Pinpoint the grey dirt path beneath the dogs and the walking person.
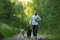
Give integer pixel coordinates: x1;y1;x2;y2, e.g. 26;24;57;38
2;33;49;40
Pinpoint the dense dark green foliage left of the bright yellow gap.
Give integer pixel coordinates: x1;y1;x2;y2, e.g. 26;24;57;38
0;0;25;37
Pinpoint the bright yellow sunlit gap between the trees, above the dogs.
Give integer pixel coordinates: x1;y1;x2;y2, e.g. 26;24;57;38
18;0;32;18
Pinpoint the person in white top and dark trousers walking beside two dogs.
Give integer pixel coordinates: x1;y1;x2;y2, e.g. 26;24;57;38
29;11;41;39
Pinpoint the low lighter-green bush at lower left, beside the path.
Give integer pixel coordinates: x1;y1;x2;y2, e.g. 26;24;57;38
0;24;18;37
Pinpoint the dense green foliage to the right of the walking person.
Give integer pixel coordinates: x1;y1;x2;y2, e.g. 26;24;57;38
34;0;60;37
